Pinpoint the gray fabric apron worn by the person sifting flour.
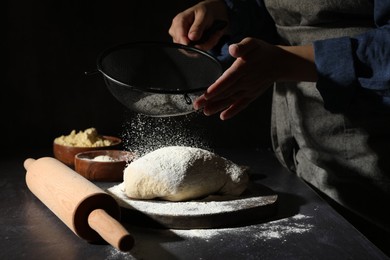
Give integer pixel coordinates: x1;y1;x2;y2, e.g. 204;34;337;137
264;0;390;231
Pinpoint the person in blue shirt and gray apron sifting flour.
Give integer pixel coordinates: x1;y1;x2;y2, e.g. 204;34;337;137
169;0;390;253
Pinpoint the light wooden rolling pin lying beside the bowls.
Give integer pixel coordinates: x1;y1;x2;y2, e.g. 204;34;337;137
24;157;134;252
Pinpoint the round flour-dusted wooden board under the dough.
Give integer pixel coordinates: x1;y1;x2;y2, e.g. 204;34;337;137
107;184;278;229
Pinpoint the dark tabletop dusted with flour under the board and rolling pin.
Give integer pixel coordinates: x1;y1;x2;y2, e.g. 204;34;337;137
0;147;388;259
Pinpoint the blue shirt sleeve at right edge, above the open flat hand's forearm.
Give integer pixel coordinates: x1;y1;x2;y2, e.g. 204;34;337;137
314;0;390;112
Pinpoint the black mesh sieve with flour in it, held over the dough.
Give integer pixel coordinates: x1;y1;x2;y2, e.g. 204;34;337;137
97;42;222;117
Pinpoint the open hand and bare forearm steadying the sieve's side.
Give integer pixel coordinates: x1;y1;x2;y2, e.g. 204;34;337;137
194;38;317;120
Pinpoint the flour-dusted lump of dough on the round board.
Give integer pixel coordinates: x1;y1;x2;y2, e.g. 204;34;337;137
123;146;248;201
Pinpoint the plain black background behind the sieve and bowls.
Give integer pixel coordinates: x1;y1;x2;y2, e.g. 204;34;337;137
0;0;270;153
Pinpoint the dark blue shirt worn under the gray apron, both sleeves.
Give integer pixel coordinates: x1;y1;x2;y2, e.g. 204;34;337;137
222;0;390;112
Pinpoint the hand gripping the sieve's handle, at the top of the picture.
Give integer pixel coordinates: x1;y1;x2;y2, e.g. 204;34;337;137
169;0;228;51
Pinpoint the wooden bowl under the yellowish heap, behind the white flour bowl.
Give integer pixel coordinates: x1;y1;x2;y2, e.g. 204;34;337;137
53;135;122;169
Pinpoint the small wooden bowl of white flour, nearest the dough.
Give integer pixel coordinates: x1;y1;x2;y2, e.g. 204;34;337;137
74;150;135;182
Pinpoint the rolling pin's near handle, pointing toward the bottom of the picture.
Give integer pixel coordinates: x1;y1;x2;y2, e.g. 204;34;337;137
88;209;134;252
